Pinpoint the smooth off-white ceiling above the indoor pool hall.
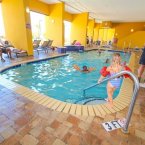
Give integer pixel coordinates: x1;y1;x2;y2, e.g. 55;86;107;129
40;0;145;22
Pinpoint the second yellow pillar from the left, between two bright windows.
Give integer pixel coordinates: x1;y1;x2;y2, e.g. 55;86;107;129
46;3;64;46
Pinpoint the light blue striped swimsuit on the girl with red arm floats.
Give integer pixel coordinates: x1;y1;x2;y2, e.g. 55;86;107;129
109;73;122;88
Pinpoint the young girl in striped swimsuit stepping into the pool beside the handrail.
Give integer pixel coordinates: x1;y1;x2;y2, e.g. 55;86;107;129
98;53;124;107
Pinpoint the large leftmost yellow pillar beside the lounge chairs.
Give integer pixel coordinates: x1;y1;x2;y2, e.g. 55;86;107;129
2;0;33;55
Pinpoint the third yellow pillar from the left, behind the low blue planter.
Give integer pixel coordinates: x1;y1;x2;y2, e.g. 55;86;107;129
71;12;89;45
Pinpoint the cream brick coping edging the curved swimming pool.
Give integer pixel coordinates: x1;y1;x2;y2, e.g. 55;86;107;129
0;54;134;117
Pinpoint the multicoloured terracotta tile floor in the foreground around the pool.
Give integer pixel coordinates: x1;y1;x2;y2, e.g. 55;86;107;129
0;50;145;145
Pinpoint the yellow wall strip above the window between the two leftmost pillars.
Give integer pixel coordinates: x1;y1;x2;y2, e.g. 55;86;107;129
29;0;50;15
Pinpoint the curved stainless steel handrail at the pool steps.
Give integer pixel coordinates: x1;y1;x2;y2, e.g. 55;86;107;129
83;71;139;133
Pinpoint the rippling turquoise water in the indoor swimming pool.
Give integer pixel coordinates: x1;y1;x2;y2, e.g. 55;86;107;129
2;51;129;103
